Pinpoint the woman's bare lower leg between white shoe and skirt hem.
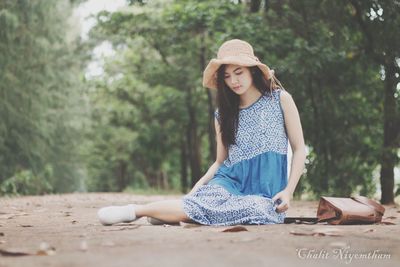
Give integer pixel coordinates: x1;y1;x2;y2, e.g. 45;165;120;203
135;199;190;223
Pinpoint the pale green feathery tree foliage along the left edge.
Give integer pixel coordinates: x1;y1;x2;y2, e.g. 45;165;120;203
0;0;85;193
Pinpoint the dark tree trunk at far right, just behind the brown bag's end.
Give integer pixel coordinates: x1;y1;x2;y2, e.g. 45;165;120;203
380;58;399;204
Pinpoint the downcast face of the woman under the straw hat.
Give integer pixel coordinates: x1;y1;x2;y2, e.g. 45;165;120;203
224;65;253;95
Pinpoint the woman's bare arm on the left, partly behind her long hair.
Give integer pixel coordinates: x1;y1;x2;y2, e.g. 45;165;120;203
189;119;228;194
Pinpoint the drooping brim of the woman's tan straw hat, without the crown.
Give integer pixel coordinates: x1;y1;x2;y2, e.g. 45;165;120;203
203;56;271;89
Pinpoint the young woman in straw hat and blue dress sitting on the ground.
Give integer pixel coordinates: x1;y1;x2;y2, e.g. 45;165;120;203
98;39;306;225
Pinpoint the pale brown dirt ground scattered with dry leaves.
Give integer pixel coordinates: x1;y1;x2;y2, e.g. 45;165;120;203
0;193;400;267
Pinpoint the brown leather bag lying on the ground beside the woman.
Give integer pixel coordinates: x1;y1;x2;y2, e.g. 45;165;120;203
317;196;385;224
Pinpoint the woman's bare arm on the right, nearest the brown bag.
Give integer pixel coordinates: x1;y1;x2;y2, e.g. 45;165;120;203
273;91;306;211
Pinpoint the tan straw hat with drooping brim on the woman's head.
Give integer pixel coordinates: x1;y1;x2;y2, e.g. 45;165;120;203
203;39;273;89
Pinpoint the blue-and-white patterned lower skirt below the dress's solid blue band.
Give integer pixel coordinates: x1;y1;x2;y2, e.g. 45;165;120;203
183;184;286;226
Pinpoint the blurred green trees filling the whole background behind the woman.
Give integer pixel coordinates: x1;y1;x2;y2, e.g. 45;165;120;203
0;0;400;204
